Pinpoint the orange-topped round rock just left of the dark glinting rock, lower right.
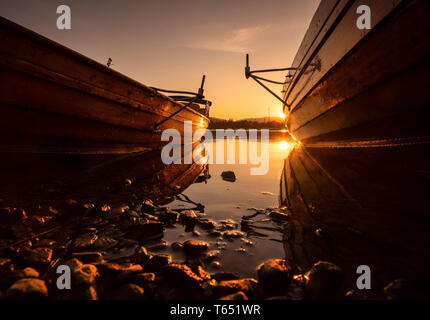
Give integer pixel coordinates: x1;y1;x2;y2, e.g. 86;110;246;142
257;259;293;295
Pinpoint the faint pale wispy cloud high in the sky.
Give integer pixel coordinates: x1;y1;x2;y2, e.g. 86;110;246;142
189;26;268;53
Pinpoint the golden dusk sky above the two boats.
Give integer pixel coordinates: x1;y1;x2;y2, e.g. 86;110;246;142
0;0;319;119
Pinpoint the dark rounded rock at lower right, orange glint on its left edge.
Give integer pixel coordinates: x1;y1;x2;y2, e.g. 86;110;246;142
304;261;344;300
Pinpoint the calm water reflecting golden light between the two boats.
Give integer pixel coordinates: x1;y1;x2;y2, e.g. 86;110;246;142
160;136;294;277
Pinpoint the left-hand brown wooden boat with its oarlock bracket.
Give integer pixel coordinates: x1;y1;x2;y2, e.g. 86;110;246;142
0;17;210;154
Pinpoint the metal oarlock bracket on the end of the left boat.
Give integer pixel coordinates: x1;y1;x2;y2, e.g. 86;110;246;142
151;75;212;130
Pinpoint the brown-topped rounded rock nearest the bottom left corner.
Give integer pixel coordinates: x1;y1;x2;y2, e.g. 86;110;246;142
6;278;48;300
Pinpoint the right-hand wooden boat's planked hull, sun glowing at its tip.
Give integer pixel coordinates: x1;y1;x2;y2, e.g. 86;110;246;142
284;0;430;144
